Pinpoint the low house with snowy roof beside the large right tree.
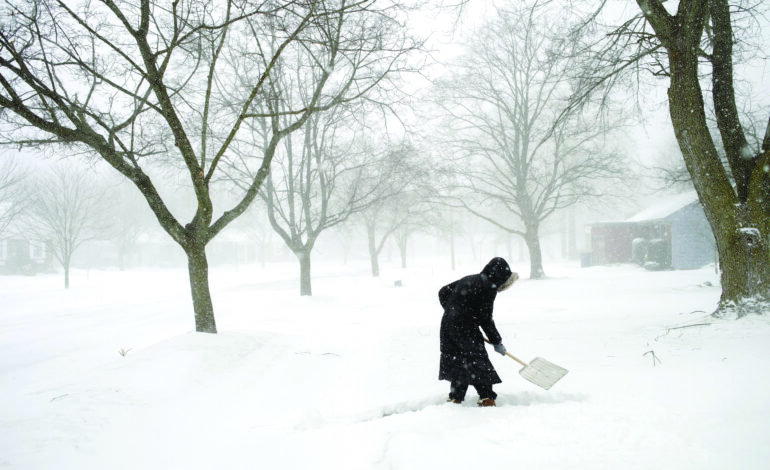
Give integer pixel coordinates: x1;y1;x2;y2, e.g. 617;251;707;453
584;191;715;269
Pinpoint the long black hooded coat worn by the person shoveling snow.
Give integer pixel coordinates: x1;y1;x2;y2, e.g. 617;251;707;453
438;258;511;384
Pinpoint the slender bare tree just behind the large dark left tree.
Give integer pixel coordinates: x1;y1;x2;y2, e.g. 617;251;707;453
262;110;396;295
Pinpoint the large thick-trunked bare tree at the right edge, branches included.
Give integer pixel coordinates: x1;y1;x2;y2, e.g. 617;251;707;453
574;0;770;316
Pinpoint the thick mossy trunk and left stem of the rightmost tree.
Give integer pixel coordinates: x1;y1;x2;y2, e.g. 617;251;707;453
667;4;770;316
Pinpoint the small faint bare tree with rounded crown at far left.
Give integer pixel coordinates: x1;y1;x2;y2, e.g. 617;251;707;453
25;163;108;289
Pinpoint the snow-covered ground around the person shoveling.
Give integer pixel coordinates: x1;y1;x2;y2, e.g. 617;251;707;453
0;262;770;470
